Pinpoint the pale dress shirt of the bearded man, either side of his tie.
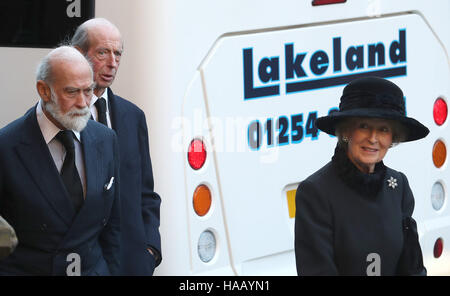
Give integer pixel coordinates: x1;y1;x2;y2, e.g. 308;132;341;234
36;101;86;197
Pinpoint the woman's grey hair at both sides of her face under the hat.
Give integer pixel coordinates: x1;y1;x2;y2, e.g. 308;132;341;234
335;117;408;148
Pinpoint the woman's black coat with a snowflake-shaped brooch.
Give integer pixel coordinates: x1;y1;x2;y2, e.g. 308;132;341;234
295;150;422;275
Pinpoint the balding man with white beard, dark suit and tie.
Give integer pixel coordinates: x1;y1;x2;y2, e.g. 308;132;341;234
0;46;120;275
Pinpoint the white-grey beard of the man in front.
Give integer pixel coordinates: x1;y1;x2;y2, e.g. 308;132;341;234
43;89;91;132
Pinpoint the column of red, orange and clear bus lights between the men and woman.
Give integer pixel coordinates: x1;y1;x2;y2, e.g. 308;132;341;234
188;139;217;263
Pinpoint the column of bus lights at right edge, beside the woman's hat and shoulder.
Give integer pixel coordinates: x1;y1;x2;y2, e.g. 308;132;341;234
431;98;448;258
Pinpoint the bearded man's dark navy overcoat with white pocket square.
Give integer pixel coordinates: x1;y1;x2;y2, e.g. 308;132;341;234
0;108;120;275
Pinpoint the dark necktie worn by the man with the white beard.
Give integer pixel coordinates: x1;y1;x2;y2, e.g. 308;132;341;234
56;130;84;212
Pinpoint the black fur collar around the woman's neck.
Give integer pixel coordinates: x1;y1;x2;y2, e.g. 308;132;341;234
332;144;386;198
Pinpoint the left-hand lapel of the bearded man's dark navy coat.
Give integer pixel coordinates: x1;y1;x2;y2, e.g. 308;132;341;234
16;108;75;225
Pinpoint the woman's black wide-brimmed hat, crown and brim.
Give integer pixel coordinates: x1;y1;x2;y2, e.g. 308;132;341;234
316;77;430;142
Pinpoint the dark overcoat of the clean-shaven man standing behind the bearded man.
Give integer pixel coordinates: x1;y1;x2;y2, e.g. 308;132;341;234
107;88;161;275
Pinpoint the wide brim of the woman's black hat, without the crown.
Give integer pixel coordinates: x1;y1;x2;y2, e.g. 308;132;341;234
315;108;430;142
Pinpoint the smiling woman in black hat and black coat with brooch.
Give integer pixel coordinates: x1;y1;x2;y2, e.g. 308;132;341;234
295;77;429;275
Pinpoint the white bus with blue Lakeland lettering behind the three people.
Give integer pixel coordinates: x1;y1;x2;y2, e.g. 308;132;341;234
0;0;450;275
